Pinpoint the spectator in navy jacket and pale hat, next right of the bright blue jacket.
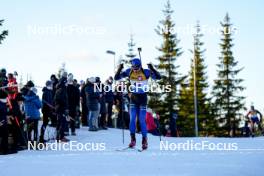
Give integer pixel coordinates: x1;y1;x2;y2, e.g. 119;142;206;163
39;81;55;143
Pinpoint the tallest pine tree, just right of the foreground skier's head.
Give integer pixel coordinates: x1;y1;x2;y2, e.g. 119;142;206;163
149;1;183;136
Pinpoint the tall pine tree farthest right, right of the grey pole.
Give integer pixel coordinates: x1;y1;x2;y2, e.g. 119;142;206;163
212;14;245;136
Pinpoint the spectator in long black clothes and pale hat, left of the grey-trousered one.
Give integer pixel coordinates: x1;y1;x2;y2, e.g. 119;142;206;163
67;73;80;136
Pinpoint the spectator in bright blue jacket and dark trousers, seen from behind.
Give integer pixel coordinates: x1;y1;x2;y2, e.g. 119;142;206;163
24;87;42;142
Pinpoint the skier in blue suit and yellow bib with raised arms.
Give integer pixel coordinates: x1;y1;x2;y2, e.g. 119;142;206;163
115;58;161;150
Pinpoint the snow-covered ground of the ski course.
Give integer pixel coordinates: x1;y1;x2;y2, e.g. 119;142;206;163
0;128;264;176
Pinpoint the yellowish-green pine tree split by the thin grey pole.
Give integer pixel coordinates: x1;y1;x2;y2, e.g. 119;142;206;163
178;22;213;136
